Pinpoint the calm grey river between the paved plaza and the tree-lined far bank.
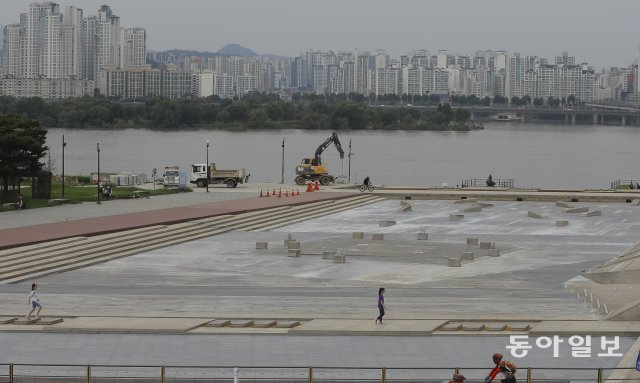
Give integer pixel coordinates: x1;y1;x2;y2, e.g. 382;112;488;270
47;122;640;189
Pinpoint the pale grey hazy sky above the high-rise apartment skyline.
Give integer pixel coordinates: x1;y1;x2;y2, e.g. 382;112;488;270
0;0;640;68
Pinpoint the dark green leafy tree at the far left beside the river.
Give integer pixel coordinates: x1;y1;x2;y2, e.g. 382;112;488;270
0;114;49;198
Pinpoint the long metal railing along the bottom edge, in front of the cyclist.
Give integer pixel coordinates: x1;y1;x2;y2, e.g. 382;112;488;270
0;363;638;383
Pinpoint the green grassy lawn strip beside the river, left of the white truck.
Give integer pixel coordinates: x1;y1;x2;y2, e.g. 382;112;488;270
0;181;192;211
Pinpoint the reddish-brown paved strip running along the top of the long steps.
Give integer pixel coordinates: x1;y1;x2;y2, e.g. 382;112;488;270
0;192;354;249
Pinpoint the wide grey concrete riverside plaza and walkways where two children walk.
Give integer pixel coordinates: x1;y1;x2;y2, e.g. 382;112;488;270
0;185;640;379
